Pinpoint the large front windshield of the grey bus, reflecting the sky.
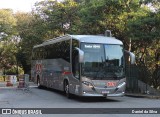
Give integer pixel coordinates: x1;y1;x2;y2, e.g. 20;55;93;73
81;43;124;80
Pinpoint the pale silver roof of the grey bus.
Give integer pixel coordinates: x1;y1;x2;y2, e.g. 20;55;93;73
34;35;123;48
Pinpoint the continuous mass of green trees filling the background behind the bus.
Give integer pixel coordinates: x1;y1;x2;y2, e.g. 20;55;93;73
0;0;160;88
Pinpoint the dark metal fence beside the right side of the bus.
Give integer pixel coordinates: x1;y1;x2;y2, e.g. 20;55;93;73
126;65;160;95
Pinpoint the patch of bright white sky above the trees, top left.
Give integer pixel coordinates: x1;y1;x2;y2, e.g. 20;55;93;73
0;0;43;12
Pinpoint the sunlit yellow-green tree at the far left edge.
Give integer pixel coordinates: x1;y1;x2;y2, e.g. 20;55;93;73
0;9;17;74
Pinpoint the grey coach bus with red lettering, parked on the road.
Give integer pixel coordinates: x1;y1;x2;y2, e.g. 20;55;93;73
31;34;135;98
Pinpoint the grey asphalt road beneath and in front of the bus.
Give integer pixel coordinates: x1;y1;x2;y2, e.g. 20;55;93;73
0;82;160;117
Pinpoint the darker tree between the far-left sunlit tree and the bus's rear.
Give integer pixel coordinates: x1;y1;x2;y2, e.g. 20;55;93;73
15;12;45;73
